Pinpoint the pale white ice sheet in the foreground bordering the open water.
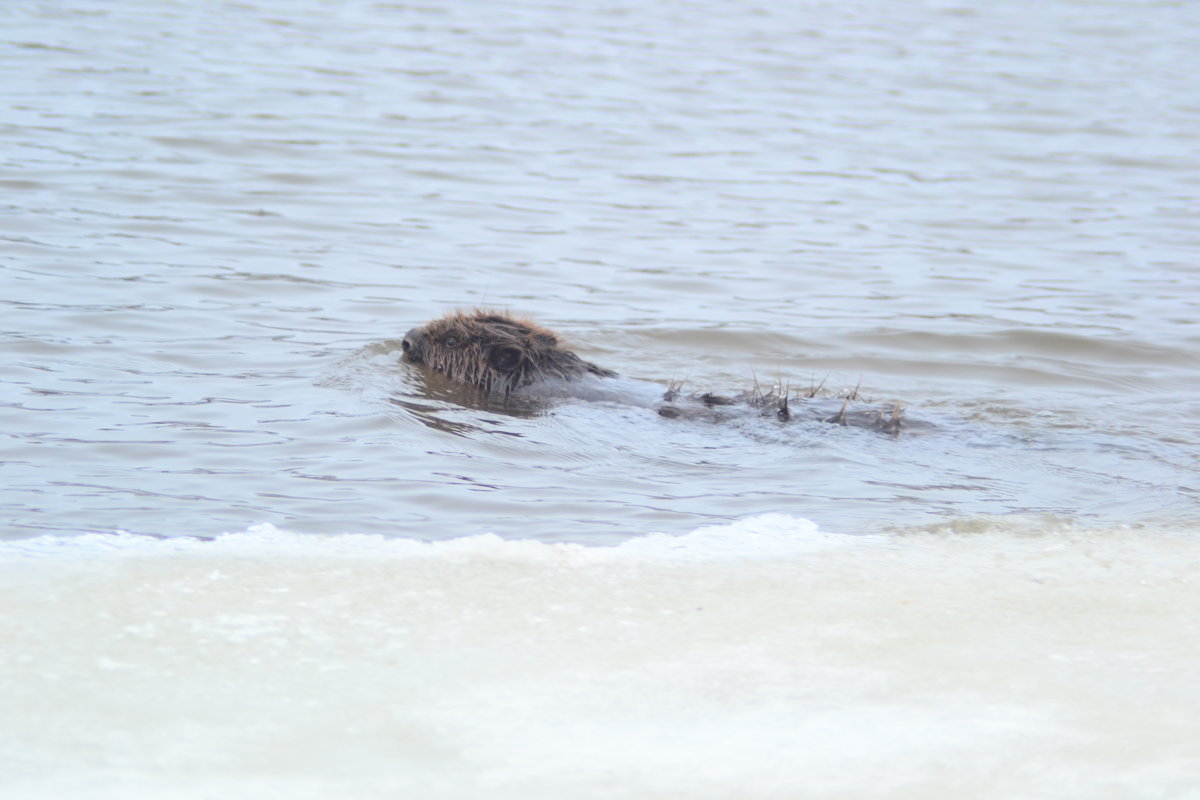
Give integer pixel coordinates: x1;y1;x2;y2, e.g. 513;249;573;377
0;515;1200;798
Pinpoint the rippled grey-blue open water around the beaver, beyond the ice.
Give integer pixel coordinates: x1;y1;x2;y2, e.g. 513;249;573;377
2;2;1200;541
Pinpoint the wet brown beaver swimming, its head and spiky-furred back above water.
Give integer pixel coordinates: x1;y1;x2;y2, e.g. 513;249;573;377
401;309;900;433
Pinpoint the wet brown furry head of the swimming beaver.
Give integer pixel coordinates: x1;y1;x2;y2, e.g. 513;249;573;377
402;311;617;399
